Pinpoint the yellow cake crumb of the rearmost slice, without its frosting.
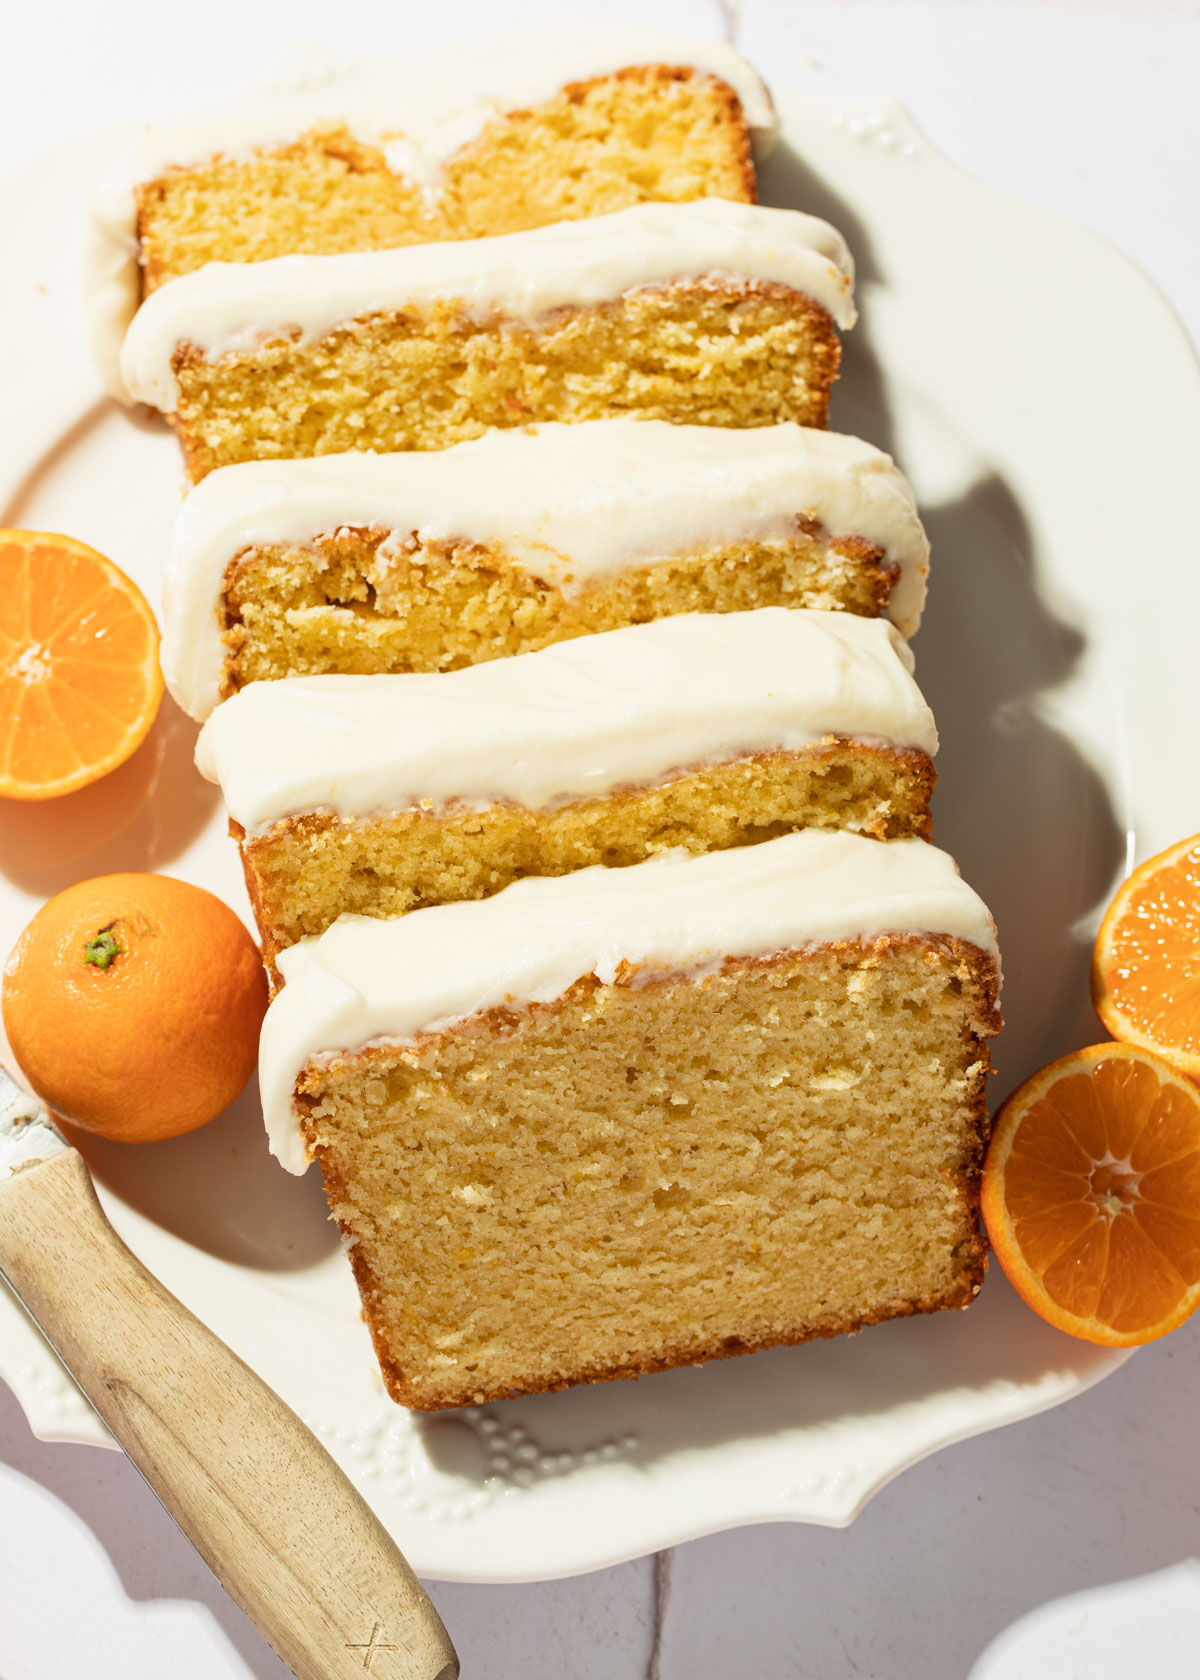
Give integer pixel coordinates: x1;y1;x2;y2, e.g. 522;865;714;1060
138;66;755;292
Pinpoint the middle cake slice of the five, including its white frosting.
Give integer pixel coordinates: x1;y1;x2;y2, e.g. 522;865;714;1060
163;420;929;719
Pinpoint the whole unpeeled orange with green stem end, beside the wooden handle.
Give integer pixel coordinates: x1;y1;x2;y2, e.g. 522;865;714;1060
2;875;267;1142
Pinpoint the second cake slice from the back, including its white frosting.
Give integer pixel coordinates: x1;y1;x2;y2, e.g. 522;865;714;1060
121;198;854;480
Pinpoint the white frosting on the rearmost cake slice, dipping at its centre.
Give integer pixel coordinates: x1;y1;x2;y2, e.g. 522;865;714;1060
84;22;778;396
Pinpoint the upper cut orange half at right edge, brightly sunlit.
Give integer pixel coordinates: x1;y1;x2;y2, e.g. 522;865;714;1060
1092;835;1200;1079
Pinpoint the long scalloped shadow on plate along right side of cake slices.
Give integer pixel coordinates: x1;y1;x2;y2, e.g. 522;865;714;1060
760;127;1129;1075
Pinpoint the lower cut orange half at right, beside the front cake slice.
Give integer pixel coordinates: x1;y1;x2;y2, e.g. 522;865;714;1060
983;1045;1200;1347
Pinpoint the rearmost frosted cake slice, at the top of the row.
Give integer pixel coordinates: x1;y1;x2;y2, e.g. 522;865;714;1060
89;24;776;393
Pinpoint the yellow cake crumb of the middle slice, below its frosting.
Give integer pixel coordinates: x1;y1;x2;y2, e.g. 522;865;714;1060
216;519;899;696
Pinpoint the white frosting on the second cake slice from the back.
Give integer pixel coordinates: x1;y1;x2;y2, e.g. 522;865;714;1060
121;198;855;413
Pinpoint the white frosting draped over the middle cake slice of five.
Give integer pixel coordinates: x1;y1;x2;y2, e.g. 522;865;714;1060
161;420;929;719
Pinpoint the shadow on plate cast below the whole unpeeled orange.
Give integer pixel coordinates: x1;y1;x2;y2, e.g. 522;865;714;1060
64;1079;338;1272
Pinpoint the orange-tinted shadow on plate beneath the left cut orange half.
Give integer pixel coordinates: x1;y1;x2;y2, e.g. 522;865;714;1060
0;696;220;897
